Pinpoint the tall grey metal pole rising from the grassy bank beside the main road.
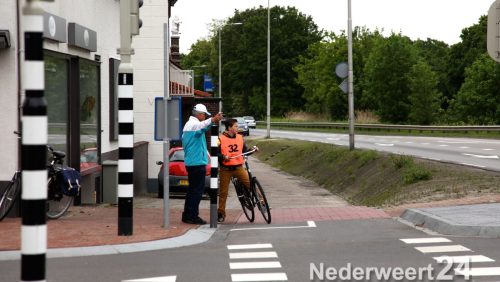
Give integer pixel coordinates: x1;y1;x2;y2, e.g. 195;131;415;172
347;0;354;150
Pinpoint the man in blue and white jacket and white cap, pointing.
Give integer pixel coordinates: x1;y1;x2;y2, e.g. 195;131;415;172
182;104;222;224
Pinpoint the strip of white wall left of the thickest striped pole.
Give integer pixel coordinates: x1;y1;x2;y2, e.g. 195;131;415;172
0;0;18;181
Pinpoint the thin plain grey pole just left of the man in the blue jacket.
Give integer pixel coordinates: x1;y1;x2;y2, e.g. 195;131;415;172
163;21;170;229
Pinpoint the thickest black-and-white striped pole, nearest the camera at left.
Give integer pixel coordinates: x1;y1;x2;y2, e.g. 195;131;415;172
21;1;48;281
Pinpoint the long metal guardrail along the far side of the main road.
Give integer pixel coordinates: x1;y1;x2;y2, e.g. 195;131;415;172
257;121;500;132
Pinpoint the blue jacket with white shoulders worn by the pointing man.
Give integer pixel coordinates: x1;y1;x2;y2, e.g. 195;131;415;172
182;116;212;166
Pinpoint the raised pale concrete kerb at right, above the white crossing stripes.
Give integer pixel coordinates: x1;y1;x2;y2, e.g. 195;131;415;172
401;209;500;238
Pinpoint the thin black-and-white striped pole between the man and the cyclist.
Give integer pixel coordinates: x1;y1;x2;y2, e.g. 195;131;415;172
210;124;219;228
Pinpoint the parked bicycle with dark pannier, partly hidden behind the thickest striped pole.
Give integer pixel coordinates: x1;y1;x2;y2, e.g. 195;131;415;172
0;138;80;221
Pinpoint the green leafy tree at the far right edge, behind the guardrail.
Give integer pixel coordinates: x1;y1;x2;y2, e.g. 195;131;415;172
450;53;500;125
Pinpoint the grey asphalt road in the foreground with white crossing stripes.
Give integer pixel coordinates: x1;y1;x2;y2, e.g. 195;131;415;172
0;219;500;282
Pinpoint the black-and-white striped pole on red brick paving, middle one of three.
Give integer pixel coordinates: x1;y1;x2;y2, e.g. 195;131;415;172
118;69;134;236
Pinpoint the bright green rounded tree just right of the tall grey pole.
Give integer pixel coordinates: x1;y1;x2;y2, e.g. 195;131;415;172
364;34;417;123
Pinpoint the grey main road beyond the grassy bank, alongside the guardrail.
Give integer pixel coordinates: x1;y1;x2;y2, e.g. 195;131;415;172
250;129;500;171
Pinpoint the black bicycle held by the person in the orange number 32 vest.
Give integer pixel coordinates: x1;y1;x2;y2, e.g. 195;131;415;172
231;147;271;224
